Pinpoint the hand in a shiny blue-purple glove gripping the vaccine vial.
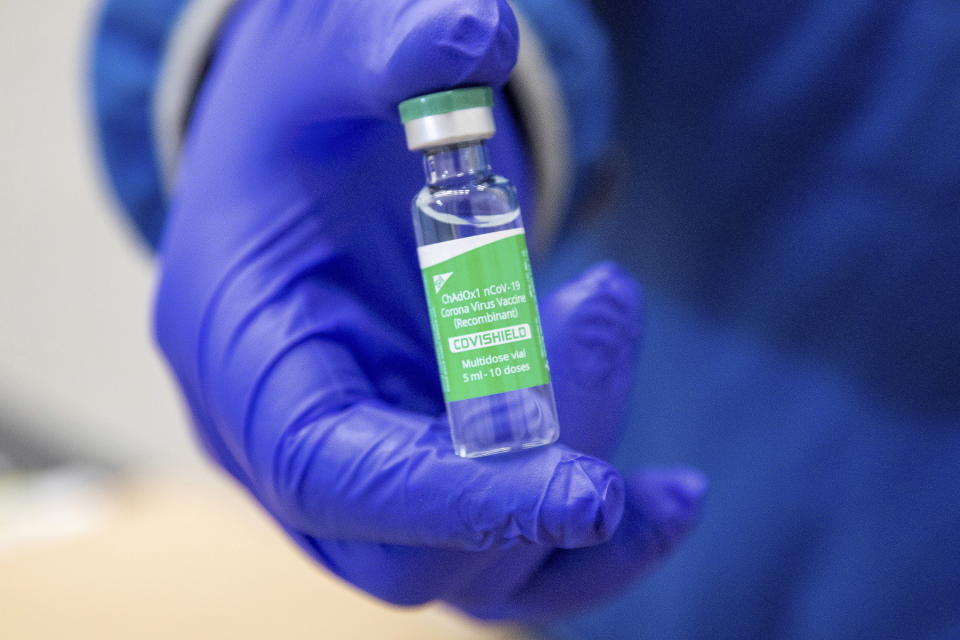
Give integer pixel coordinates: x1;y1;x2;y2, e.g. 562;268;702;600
156;0;704;619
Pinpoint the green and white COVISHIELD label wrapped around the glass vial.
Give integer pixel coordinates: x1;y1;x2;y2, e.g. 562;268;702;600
418;229;550;402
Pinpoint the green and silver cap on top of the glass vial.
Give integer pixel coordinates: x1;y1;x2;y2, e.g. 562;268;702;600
397;87;496;151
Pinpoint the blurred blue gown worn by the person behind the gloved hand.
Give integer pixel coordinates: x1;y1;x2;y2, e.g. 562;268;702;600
97;0;960;640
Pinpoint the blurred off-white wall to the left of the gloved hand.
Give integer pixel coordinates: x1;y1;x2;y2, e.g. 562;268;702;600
0;0;198;476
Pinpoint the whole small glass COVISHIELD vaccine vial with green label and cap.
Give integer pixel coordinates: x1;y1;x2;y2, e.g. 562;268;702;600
399;87;559;458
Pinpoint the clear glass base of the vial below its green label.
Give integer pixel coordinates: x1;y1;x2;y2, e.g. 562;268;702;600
447;384;560;458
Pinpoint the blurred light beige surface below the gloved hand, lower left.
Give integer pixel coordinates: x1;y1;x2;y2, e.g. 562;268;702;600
0;472;519;640
